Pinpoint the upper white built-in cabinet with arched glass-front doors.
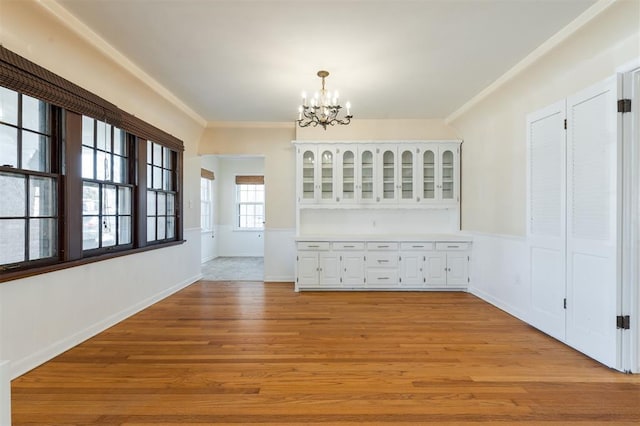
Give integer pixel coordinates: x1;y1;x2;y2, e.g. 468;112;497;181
296;141;460;207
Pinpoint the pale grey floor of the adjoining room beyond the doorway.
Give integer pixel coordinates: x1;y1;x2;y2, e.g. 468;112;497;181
202;257;264;281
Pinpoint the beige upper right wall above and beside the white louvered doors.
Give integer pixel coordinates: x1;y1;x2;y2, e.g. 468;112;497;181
451;0;640;235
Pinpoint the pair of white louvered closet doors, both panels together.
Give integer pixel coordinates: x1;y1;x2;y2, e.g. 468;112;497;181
527;78;622;368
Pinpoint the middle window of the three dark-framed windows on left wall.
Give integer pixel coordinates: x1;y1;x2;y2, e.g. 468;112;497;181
82;116;133;250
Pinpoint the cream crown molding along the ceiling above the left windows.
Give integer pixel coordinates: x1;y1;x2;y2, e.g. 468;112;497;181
36;0;207;127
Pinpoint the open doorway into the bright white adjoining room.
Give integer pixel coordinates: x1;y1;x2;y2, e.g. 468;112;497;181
201;155;266;281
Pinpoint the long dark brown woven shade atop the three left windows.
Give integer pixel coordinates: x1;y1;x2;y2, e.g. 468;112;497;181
0;46;184;151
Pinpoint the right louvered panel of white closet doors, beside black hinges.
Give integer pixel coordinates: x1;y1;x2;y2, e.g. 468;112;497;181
567;78;621;367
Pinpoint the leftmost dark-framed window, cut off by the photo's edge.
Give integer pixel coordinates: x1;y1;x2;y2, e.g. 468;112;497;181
0;87;59;267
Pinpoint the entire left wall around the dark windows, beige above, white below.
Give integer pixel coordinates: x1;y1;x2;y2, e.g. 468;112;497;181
0;0;204;382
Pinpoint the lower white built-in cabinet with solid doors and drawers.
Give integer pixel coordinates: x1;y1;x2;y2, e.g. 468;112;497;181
296;240;471;290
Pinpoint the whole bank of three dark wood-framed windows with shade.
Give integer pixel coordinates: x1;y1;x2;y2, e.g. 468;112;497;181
0;46;184;282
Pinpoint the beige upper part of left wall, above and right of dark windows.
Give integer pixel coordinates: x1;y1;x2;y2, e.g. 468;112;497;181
0;0;204;228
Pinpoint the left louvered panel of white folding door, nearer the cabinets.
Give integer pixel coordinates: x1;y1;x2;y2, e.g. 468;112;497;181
527;101;566;340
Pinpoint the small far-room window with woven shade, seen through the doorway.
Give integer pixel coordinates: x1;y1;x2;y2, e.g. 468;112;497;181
236;176;264;230
